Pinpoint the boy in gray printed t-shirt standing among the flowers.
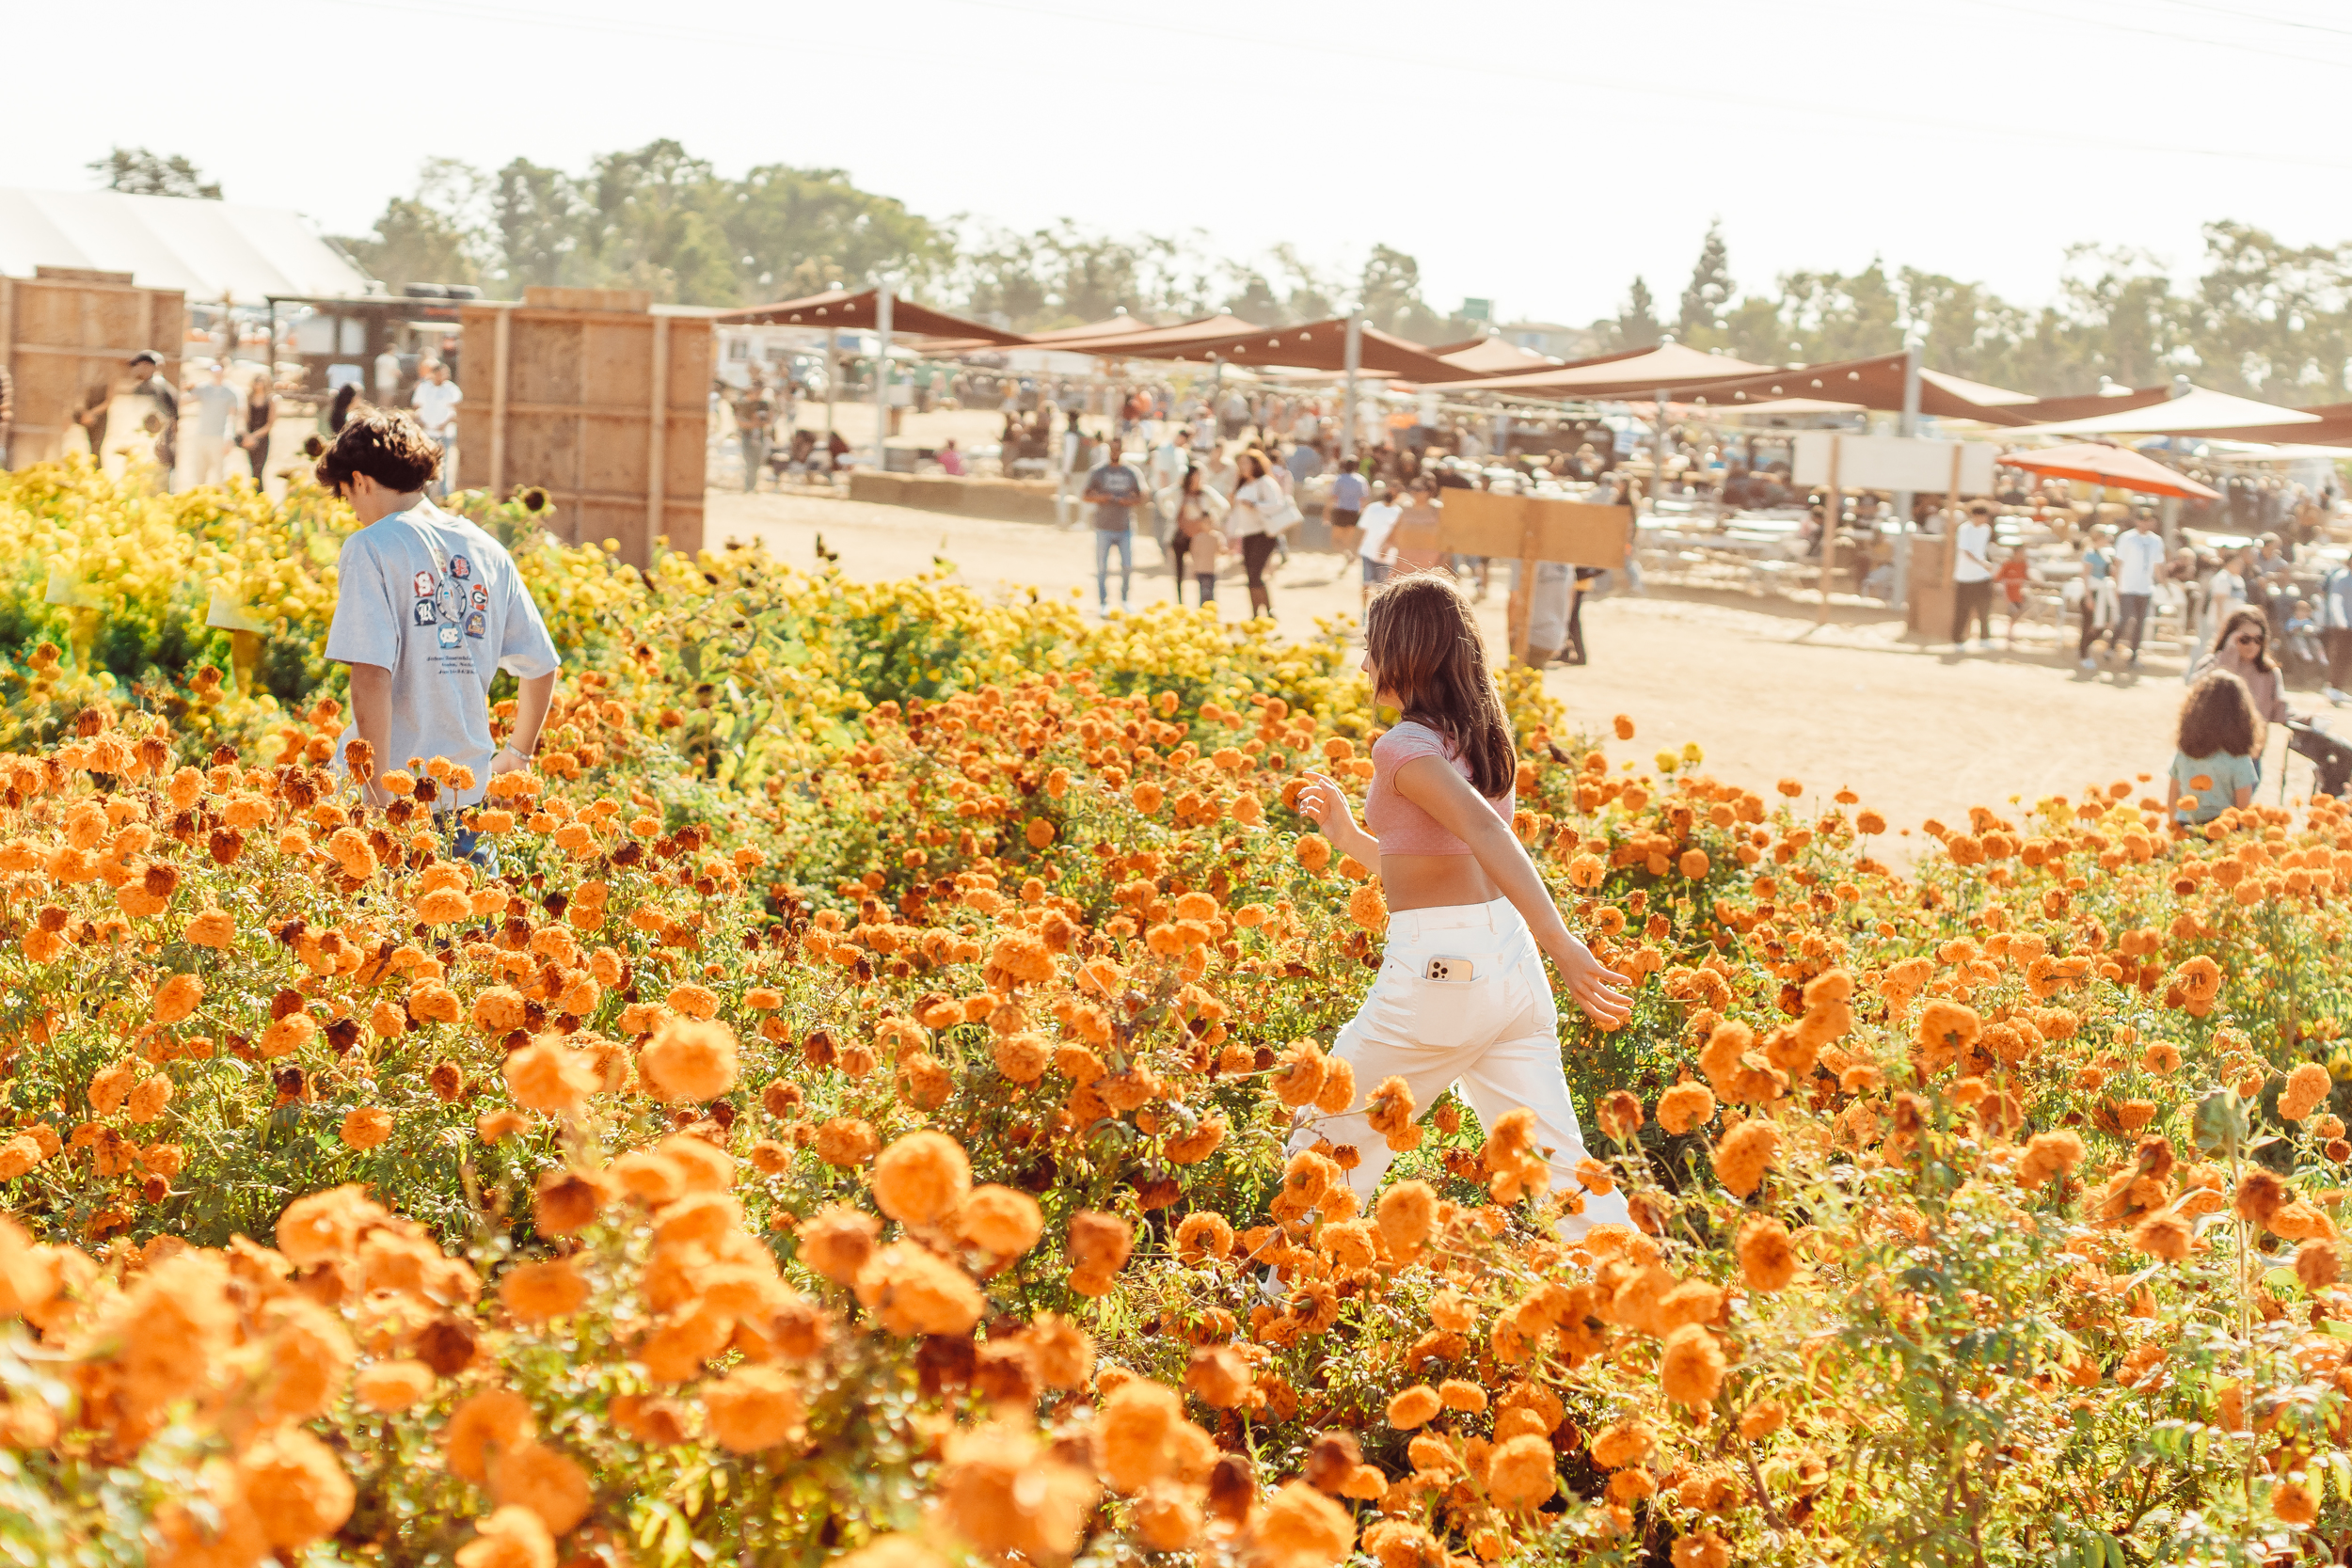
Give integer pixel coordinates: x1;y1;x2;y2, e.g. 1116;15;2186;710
318;409;563;811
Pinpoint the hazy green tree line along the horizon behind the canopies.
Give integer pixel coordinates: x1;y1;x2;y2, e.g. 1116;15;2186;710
89;141;2352;404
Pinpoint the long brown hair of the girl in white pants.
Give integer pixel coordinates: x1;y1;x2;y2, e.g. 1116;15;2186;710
1364;571;1519;800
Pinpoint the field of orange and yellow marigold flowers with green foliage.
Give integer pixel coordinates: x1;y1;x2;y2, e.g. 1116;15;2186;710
0;472;2352;1568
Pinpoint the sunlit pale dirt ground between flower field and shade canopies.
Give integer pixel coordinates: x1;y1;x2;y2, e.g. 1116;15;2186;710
706;491;2314;861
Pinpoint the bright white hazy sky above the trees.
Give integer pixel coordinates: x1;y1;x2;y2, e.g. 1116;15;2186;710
18;0;2352;322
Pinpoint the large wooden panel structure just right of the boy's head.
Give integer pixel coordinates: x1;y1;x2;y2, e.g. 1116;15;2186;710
459;289;710;566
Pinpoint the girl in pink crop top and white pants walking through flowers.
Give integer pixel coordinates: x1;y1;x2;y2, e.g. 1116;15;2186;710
1292;571;1632;1239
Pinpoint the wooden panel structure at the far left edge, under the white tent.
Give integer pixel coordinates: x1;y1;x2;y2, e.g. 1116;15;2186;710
0;265;188;467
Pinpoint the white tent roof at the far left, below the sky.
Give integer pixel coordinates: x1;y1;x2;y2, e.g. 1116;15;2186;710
0;188;381;306
